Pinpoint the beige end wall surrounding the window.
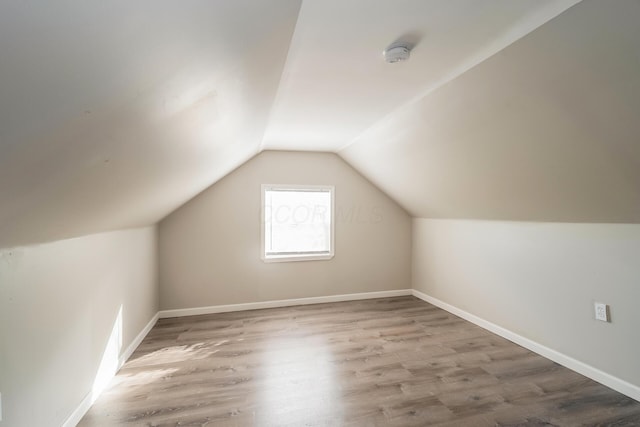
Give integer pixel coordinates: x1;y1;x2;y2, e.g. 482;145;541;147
159;151;411;309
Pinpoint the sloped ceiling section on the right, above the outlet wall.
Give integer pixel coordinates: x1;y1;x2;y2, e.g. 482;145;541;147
340;1;640;223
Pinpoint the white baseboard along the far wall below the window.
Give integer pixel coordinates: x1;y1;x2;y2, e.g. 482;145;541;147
159;289;412;319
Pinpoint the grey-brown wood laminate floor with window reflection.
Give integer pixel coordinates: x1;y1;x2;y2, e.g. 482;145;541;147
79;297;640;427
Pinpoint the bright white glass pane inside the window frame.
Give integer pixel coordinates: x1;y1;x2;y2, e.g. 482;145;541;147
265;190;331;255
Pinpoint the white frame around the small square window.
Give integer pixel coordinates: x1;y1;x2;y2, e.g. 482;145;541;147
260;184;335;262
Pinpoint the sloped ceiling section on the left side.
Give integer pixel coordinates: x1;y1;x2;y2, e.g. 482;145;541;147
0;0;300;247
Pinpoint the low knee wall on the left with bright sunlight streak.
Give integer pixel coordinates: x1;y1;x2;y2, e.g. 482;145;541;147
0;227;158;427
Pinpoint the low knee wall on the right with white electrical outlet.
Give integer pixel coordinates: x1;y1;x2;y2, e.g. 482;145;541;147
413;219;640;386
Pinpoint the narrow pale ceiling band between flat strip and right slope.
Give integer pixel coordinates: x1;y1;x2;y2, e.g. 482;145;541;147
336;0;582;155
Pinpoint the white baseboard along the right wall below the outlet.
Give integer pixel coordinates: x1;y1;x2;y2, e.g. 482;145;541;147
412;289;640;401
